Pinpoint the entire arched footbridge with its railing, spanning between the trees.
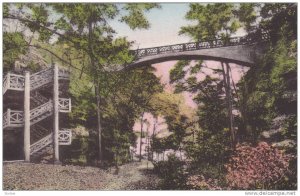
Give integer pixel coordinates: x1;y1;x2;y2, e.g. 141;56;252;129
127;33;269;69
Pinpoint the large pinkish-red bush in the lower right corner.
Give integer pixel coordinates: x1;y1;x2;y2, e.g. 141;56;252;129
225;142;291;189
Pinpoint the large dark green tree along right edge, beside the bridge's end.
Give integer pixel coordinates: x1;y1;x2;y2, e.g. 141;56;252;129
238;3;296;142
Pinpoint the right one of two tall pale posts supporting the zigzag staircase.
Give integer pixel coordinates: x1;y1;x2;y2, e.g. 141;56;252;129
53;65;60;164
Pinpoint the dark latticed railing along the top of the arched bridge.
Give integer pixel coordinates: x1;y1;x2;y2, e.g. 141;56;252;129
132;33;269;59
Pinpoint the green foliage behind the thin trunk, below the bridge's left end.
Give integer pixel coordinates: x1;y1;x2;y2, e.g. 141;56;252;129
71;67;164;165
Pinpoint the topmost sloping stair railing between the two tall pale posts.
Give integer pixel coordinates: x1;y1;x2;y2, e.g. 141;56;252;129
30;68;53;90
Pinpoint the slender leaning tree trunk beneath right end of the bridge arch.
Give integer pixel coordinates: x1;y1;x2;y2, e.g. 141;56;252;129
221;62;235;148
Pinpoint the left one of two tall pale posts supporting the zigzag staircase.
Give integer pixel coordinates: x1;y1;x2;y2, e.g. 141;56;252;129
24;72;30;162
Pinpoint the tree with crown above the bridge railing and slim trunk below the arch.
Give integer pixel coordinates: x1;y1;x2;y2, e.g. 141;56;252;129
176;3;240;148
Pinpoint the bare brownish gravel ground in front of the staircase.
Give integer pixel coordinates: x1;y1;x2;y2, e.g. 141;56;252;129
3;161;159;190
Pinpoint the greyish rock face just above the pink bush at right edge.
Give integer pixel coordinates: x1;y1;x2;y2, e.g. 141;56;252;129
261;115;297;149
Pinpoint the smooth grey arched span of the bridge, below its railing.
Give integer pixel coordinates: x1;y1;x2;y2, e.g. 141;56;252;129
128;45;262;69
